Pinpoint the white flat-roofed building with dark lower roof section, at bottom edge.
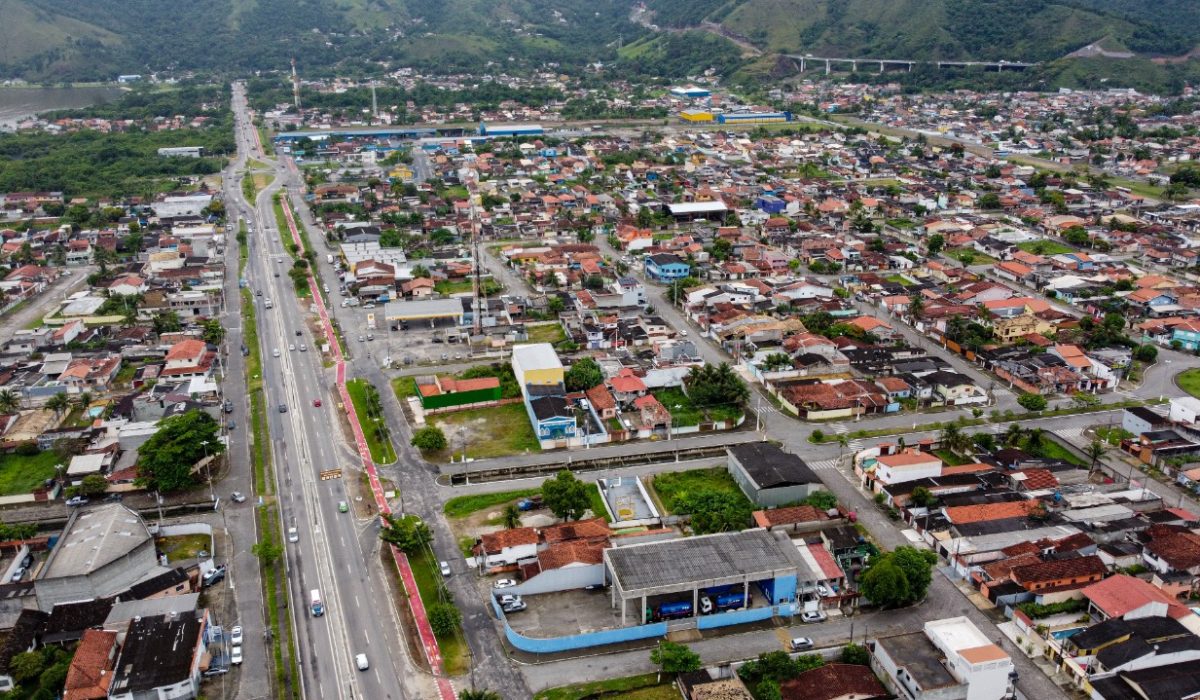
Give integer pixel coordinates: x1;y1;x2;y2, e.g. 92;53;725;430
870;617;1013;700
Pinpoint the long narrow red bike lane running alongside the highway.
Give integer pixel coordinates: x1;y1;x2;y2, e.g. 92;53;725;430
278;192;457;700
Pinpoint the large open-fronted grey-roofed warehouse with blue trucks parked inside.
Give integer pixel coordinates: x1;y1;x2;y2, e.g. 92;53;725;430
604;530;816;626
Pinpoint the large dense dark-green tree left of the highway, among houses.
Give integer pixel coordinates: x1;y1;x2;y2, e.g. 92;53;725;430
137;409;224;492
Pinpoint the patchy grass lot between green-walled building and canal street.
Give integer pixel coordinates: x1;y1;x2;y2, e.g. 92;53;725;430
428;403;541;461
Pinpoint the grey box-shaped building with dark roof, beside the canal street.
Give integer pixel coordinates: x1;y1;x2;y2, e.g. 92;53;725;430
728;442;824;508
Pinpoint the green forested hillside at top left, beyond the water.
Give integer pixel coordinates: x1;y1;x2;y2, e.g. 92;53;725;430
0;0;644;80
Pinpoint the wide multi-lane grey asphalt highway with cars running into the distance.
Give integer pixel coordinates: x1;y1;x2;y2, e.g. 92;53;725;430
229;85;424;700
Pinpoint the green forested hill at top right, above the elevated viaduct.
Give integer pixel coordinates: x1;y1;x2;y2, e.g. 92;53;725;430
646;0;1200;61
